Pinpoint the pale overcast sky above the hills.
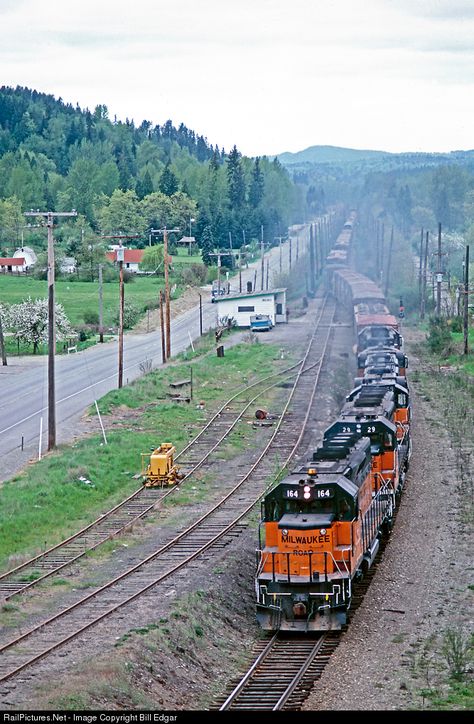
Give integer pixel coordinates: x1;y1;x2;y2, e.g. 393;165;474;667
0;0;474;156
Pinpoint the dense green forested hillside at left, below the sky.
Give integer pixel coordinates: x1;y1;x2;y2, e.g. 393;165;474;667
0;87;299;254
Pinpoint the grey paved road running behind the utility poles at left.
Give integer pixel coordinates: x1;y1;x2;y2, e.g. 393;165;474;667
0;230;308;481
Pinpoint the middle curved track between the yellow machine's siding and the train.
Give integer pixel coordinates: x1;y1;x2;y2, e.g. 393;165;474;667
0;300;335;694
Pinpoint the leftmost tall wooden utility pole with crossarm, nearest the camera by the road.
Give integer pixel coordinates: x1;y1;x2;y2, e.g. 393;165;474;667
24;211;77;450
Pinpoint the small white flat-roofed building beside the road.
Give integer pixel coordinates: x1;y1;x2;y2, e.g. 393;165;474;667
212;289;287;327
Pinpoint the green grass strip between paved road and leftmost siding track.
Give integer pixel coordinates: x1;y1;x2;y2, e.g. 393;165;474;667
0;344;288;570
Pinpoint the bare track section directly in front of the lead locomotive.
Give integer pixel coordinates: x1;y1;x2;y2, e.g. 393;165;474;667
216;631;340;711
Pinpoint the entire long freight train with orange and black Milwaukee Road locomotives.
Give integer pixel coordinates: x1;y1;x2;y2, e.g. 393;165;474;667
255;214;410;632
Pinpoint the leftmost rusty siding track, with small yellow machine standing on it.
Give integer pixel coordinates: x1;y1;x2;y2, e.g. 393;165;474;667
0;350;301;601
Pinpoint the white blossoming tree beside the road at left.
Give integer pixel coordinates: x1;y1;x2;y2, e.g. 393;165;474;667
5;297;72;354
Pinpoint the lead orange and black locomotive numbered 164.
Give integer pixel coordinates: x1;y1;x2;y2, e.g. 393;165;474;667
256;435;372;632
